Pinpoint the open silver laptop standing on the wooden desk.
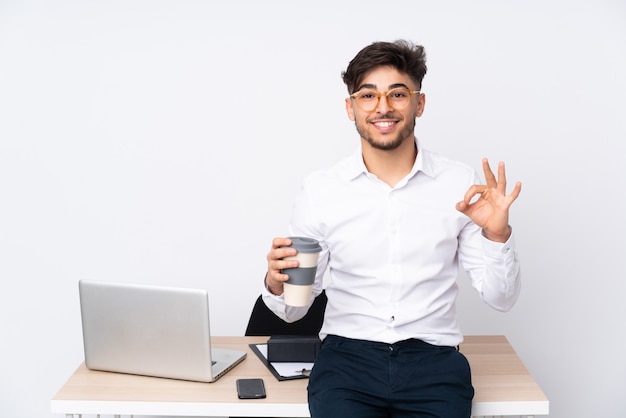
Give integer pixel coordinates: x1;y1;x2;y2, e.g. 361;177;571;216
78;280;246;382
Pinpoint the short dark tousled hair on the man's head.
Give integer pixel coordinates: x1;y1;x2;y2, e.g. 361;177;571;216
341;39;426;94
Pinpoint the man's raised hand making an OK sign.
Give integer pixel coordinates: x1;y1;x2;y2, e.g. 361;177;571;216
456;158;522;242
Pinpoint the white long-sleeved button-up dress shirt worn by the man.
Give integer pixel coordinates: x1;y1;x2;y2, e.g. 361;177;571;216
263;141;521;346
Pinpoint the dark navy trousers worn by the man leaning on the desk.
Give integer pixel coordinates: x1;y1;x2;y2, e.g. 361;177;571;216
308;335;474;418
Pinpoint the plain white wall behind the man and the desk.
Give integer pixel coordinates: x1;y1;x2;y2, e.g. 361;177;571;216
0;0;626;418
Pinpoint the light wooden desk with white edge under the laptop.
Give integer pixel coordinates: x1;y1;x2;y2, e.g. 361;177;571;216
51;336;549;418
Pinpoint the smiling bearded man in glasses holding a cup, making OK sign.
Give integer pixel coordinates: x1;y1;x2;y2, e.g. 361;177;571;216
263;41;521;418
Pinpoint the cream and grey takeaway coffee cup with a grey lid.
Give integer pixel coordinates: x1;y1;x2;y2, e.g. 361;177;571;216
282;237;322;306
